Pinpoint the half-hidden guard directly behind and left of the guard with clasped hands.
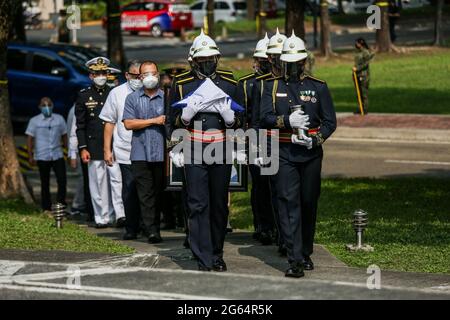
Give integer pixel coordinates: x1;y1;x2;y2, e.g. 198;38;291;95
239;33;275;245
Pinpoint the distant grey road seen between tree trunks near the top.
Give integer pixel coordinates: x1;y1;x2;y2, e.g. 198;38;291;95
27;25;450;62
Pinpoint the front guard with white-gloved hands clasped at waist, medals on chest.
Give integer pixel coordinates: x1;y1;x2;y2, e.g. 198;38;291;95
261;34;336;277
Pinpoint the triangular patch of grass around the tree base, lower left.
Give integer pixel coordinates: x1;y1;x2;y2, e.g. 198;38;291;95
0;200;134;254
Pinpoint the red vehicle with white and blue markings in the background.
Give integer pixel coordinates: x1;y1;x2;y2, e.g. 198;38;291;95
103;0;193;37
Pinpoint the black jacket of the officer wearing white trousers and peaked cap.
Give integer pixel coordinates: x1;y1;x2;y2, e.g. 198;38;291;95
75;86;110;160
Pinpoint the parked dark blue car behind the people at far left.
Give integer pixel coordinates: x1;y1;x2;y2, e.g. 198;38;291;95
7;43;119;122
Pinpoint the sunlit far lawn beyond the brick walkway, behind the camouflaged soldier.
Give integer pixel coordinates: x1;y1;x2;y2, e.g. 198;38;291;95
315;50;450;114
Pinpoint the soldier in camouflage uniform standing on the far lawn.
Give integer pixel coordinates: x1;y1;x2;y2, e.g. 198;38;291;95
353;38;375;114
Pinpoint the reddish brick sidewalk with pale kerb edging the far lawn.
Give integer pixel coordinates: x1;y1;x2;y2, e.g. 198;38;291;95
331;112;450;144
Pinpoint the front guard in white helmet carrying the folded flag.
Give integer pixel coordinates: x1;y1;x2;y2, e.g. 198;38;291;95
169;32;243;272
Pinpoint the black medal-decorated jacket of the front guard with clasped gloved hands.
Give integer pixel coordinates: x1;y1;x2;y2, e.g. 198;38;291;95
260;76;336;162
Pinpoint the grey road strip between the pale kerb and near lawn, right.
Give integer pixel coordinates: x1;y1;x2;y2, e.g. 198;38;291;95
323;137;450;178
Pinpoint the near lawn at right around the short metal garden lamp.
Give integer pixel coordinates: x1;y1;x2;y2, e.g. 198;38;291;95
231;178;450;273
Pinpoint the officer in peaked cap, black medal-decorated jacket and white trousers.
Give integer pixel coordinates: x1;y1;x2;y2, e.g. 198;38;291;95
75;57;113;228
